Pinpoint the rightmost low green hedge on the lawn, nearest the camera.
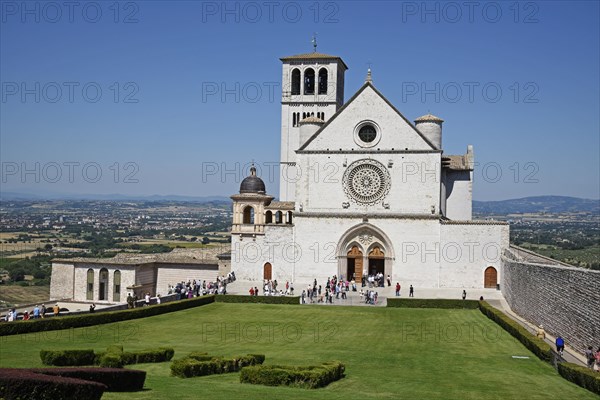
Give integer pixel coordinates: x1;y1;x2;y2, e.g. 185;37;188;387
240;361;346;389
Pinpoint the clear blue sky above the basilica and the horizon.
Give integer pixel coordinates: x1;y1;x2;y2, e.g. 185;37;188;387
0;1;600;200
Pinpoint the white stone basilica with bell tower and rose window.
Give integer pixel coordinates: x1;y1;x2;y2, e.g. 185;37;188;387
231;50;509;288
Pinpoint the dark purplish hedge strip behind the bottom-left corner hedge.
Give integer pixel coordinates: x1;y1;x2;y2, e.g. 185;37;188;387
30;368;146;392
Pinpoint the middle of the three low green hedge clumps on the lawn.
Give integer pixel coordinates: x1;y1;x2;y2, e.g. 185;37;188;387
171;353;265;378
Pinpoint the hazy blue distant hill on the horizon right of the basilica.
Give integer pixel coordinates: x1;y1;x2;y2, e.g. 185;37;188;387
473;196;600;215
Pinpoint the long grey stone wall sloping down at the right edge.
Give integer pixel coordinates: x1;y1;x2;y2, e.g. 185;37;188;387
501;253;600;352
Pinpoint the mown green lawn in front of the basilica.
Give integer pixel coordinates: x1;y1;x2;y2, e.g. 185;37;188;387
0;303;598;400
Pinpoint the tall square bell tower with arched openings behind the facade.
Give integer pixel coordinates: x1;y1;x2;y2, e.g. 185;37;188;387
279;46;348;201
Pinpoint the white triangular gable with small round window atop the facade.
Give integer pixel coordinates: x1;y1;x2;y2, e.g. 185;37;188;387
298;82;436;152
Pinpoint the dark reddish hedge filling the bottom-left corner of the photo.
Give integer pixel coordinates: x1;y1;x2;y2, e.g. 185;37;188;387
0;368;107;400
